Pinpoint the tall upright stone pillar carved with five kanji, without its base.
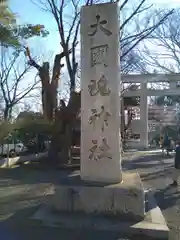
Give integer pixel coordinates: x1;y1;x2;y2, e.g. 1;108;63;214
80;3;122;183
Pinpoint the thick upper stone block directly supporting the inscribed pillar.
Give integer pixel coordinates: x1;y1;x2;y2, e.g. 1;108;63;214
49;172;145;220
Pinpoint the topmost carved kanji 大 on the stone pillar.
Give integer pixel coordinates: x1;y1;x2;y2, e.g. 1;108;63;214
88;15;112;37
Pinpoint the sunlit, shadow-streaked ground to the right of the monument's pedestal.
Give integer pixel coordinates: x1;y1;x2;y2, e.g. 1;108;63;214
124;153;180;240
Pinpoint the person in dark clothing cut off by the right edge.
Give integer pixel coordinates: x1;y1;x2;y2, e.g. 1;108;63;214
171;141;180;186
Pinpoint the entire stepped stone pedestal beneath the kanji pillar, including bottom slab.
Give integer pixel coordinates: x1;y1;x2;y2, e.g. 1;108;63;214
31;173;169;240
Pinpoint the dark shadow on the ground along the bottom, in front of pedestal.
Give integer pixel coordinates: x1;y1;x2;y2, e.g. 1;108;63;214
0;207;158;240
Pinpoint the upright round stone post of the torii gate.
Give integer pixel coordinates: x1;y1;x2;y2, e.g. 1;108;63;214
140;83;148;148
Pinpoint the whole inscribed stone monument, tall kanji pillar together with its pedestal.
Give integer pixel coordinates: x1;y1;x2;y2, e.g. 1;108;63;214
32;3;169;233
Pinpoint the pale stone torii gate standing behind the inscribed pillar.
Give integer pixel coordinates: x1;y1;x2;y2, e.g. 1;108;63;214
121;73;180;148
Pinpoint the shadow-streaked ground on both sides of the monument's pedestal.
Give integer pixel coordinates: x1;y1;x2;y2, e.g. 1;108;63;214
0;153;180;240
